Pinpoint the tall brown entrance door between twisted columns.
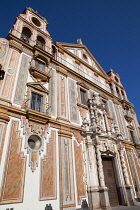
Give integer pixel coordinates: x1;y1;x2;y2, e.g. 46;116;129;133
102;157;119;206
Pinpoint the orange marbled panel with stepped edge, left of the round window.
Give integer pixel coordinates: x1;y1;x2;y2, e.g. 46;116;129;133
1;121;26;203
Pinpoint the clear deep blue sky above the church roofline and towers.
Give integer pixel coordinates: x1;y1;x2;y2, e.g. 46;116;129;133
0;0;140;120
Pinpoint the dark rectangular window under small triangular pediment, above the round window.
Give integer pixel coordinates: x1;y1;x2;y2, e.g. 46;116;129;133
31;92;43;112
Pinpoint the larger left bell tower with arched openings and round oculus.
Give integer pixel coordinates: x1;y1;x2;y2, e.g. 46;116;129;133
7;7;52;53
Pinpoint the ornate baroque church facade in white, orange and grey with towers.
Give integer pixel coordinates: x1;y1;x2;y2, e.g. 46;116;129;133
0;8;140;210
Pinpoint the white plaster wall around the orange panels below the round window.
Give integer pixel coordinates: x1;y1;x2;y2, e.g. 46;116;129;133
0;123;60;210
